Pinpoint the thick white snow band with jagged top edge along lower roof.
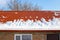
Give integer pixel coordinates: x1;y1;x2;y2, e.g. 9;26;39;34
0;18;60;30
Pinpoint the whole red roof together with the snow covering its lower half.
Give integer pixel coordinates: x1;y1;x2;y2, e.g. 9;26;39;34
0;11;60;30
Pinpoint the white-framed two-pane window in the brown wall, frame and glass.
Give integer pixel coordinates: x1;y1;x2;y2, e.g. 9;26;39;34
14;34;32;40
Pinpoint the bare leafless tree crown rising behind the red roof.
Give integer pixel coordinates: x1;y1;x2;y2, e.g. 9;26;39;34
8;0;40;11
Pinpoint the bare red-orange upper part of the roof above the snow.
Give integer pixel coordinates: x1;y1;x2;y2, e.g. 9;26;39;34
0;11;60;22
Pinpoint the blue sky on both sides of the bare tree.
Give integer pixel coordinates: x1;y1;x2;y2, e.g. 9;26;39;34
0;0;60;10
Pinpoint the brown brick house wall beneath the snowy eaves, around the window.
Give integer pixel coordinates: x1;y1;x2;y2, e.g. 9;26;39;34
0;32;56;40
